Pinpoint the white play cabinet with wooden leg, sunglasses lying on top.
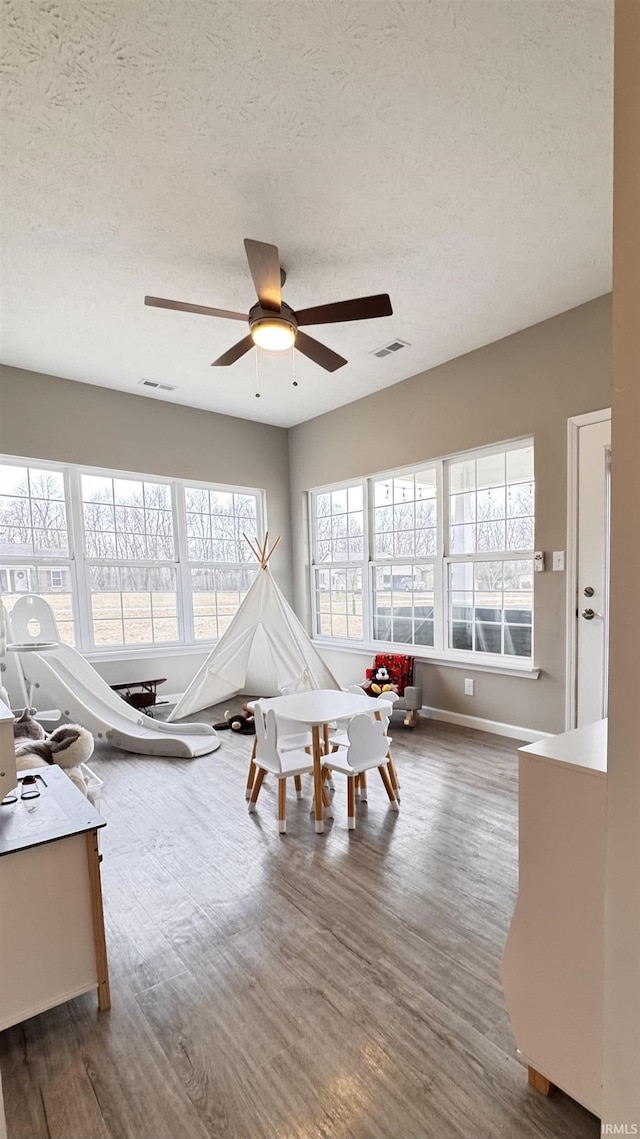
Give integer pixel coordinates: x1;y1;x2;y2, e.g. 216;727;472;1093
0;767;109;1030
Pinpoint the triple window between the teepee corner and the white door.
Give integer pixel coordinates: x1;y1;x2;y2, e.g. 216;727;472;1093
310;441;534;663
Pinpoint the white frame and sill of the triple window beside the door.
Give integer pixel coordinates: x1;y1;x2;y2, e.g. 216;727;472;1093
306;435;539;675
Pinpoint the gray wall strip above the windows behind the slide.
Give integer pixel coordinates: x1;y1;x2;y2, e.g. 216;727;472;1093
0;364;292;599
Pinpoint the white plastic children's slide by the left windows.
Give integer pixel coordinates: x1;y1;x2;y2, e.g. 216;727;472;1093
4;593;220;759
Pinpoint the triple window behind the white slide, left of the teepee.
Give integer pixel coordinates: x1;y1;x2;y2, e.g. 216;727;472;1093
0;459;263;649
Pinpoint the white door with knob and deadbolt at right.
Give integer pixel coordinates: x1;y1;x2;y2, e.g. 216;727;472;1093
575;418;612;728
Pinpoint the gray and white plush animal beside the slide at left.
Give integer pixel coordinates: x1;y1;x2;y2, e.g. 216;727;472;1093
14;708;93;795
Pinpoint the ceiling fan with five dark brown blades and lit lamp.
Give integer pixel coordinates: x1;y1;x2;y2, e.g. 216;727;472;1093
145;237;393;371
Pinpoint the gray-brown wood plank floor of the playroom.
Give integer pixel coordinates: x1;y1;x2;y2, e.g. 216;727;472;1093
0;713;599;1139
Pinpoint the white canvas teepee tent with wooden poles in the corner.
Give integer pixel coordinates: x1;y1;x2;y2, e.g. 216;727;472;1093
169;535;340;720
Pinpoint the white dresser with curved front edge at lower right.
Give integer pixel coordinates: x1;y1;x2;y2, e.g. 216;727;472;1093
500;720;607;1115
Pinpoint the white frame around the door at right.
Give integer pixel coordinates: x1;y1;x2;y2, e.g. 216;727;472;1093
565;408;612;731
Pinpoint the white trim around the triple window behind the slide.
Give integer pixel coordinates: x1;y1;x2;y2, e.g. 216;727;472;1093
0;454;266;661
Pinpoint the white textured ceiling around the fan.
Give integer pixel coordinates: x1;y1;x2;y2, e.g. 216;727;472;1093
1;0;613;425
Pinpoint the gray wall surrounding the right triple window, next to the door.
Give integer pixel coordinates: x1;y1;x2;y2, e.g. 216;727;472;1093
289;296;610;731
